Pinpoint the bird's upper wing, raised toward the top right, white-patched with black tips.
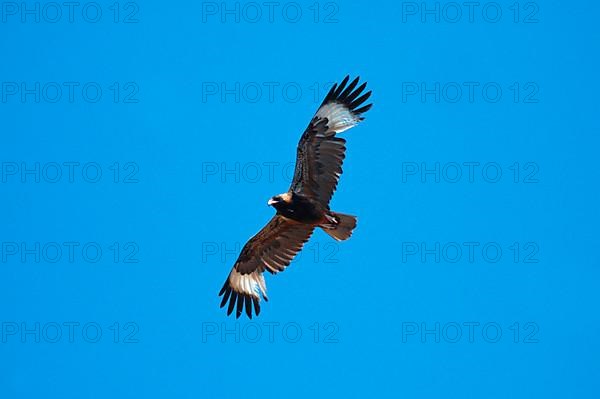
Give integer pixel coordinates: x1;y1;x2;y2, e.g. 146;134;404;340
290;76;373;207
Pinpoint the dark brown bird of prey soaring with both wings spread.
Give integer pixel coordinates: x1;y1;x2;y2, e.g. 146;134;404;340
219;76;373;319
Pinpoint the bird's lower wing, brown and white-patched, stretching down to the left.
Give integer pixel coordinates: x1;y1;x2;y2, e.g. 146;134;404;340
219;215;314;318
